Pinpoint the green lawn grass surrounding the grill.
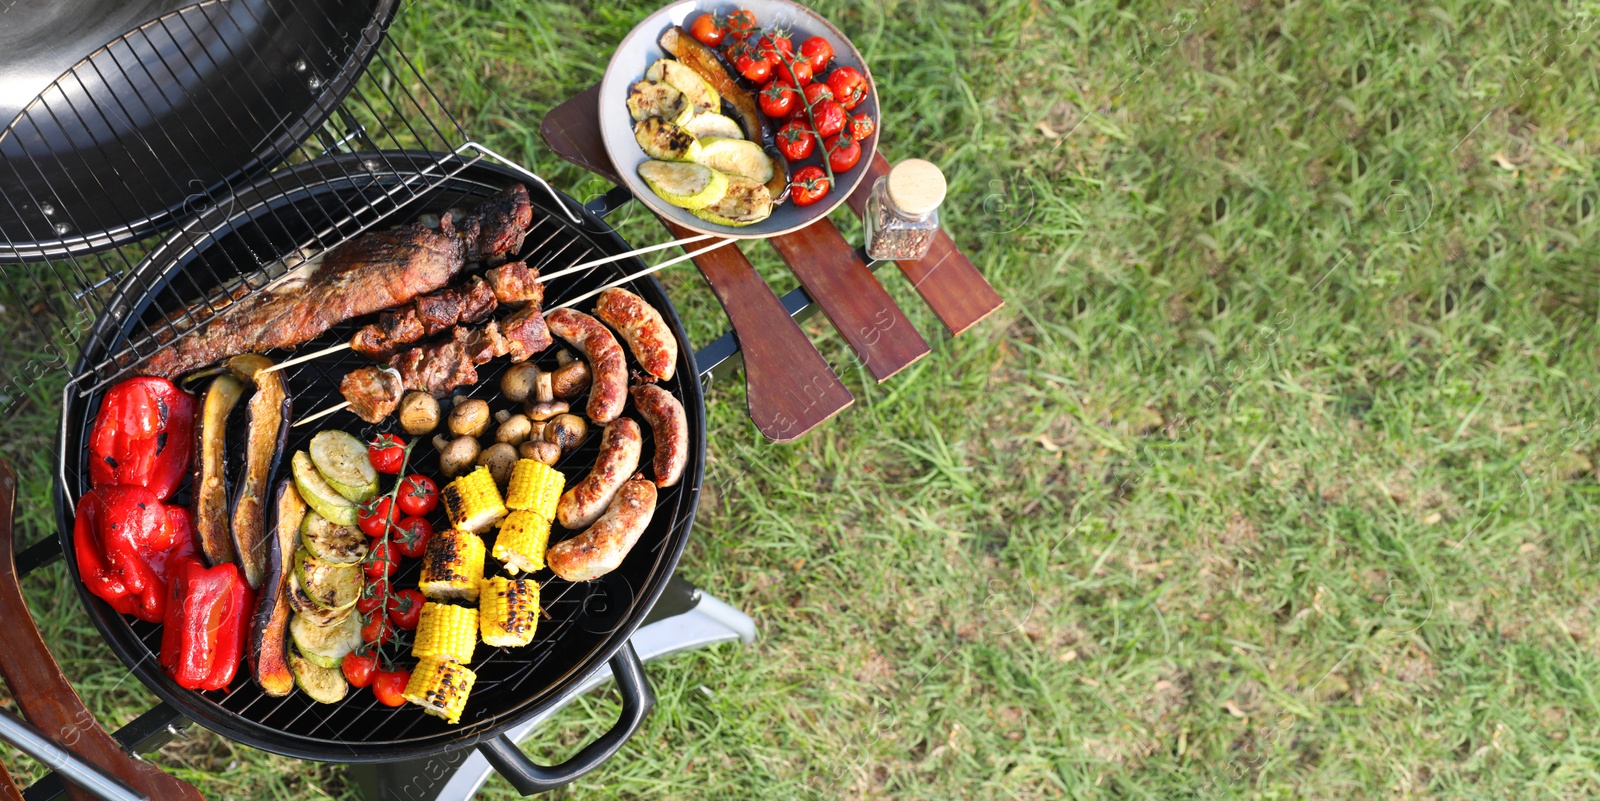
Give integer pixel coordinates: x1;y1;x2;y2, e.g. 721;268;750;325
9;0;1600;799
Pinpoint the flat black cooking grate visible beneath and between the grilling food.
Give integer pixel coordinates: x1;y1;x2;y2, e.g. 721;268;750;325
59;153;702;761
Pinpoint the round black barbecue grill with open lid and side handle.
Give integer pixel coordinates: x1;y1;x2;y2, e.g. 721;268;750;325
0;0;732;793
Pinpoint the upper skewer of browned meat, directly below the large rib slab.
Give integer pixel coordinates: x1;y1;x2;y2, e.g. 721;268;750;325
350;262;544;361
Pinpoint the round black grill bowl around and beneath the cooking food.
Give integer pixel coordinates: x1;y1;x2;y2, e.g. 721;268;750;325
56;153;706;763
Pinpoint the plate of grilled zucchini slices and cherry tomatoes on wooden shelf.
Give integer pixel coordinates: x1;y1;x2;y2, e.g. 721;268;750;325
600;0;878;238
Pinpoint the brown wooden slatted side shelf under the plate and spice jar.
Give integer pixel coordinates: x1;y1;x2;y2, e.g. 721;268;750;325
539;85;1003;441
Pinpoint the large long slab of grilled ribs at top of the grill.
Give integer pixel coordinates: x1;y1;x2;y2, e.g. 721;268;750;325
139;184;533;377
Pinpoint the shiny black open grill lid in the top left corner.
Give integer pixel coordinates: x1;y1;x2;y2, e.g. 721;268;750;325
0;0;397;262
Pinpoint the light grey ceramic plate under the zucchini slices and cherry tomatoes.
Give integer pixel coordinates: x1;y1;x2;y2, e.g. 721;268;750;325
600;0;880;240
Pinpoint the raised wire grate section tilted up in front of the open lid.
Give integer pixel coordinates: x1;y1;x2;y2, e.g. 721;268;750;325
0;0;578;393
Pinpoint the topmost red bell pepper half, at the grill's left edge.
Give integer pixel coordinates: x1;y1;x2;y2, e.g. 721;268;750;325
90;377;195;500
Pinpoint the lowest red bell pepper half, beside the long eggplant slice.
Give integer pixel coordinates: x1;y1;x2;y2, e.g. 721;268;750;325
160;556;256;689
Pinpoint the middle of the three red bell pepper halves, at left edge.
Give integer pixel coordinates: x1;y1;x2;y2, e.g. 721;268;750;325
72;484;180;624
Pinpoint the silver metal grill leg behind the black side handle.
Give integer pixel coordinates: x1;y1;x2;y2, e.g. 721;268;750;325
346;576;755;801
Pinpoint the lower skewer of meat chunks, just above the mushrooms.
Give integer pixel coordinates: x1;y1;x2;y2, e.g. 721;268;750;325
339;304;554;422
